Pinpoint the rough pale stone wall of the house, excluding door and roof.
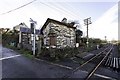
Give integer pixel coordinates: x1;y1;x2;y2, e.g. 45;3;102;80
43;23;76;48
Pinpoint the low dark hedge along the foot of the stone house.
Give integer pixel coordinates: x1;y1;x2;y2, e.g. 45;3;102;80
40;48;79;60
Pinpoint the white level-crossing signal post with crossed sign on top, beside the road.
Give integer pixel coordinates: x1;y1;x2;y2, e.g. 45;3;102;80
30;18;37;56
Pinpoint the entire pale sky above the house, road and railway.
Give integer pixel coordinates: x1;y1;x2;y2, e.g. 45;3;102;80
0;0;118;40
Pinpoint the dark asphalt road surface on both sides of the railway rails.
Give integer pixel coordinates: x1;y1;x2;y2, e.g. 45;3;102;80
0;46;119;80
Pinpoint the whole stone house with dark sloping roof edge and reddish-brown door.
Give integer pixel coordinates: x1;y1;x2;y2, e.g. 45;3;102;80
41;18;76;48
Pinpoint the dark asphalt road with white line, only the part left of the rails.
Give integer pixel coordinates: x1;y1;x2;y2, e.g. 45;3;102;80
0;47;70;78
